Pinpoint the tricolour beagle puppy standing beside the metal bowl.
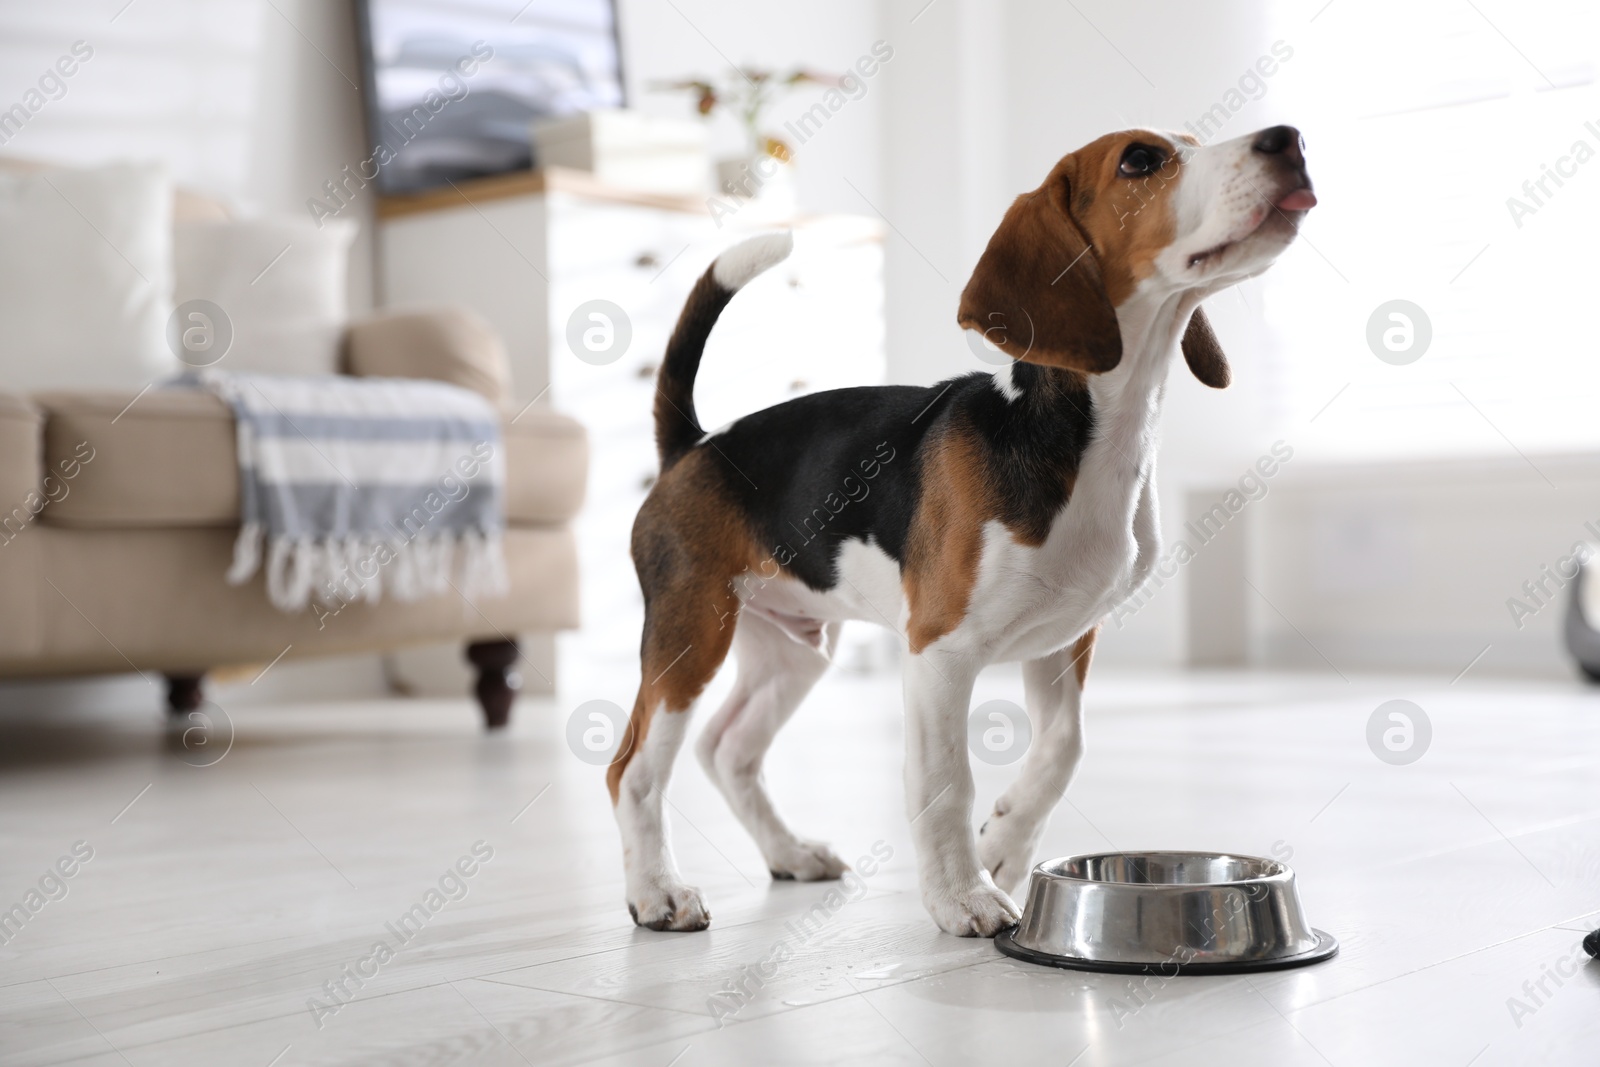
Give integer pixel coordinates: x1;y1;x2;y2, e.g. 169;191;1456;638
606;126;1317;937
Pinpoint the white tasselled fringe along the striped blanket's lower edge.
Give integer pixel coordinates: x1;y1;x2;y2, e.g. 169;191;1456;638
241;525;510;611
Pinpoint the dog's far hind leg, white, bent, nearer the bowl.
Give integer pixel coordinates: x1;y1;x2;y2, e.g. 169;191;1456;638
696;608;846;881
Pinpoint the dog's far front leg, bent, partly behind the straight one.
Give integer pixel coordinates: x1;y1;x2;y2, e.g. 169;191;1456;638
978;630;1096;893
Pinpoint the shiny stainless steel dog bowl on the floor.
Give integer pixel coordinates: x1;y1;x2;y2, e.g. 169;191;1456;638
995;853;1339;974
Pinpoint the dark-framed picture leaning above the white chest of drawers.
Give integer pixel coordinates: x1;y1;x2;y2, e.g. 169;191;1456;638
355;0;626;192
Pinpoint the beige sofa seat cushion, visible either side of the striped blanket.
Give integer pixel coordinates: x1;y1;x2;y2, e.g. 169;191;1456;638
34;389;589;528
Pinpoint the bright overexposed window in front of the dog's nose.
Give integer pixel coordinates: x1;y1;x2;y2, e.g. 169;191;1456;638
1266;0;1600;461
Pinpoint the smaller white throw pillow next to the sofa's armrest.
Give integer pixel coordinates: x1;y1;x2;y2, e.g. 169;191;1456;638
173;218;355;374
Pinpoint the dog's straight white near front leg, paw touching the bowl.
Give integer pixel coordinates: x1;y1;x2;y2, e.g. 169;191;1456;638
906;651;1022;937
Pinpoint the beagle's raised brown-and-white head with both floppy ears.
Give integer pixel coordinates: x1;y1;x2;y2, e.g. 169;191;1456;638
958;126;1317;389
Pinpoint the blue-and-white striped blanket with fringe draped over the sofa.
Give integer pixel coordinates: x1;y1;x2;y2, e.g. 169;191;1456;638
198;371;507;611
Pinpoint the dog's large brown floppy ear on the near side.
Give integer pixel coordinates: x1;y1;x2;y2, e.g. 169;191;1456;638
957;155;1122;374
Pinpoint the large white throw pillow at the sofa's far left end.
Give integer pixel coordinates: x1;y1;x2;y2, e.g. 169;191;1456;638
0;163;179;392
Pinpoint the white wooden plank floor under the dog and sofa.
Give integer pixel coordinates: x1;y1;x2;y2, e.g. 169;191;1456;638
0;669;1600;1067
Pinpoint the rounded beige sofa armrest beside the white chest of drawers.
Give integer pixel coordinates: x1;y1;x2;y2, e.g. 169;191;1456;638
344;306;510;411
